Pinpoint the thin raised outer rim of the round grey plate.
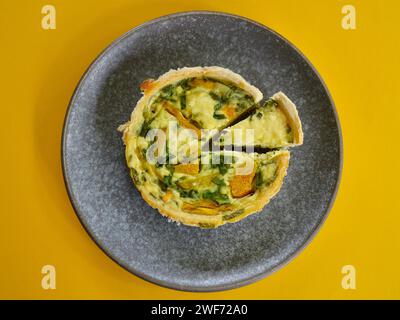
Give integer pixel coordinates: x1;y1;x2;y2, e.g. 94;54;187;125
61;10;343;292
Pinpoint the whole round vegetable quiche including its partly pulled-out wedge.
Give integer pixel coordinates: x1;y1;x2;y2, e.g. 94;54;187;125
119;67;303;228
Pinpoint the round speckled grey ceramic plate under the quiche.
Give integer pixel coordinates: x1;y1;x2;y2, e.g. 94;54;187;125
62;12;342;291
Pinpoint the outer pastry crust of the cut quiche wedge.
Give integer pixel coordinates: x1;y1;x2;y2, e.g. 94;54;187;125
272;91;303;146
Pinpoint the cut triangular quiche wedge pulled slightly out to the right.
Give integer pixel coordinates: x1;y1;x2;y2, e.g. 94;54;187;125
218;92;303;149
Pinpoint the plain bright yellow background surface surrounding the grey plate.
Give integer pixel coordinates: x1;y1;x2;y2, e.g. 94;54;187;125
0;0;400;299
